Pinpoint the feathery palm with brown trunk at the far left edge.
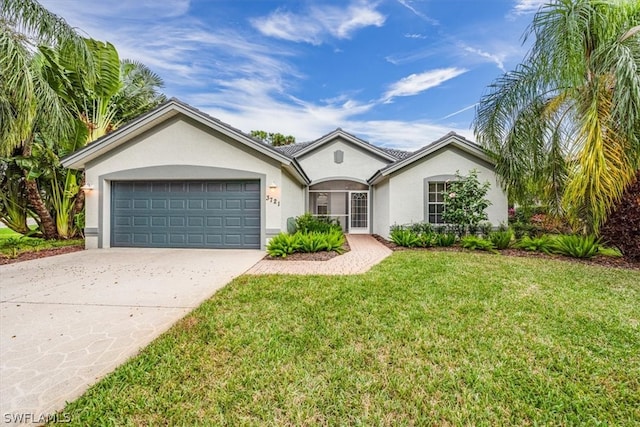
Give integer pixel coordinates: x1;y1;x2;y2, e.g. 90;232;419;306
0;0;94;238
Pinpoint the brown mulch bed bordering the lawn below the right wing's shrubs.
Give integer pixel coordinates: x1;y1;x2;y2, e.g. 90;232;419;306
373;234;640;271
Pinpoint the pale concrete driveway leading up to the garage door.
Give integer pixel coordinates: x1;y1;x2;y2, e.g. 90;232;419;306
0;249;264;424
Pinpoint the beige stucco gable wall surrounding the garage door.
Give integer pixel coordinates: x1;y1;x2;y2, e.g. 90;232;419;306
86;118;304;248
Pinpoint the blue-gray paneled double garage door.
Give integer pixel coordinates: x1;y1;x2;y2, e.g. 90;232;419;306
111;181;260;249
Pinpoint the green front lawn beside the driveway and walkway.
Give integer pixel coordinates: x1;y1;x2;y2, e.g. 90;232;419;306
56;251;640;426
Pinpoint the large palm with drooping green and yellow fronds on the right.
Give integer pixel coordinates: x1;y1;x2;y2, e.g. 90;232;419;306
474;0;640;232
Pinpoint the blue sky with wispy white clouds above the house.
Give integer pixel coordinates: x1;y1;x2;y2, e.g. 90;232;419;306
40;0;545;151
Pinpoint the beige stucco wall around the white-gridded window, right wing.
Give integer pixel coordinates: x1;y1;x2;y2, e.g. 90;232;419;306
376;146;507;237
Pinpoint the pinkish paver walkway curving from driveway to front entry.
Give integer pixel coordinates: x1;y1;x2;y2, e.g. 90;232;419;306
247;234;392;275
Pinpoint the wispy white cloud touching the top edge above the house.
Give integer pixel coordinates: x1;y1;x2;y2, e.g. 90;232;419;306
250;1;386;45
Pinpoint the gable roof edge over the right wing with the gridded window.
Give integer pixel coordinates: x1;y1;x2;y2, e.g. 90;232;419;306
368;132;495;184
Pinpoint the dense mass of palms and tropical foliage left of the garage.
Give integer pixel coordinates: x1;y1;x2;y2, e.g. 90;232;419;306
0;0;164;239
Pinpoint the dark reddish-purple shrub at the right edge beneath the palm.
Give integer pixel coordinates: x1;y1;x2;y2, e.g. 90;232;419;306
600;171;640;261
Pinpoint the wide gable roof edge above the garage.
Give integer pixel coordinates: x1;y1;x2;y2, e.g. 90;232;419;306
61;98;309;182
